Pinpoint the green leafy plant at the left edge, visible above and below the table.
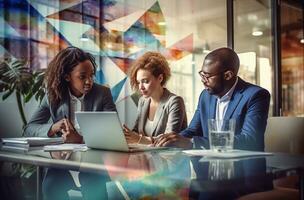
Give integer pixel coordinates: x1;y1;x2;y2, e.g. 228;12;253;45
0;58;45;197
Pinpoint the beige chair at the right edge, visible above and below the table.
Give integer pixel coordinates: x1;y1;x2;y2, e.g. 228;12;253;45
238;117;304;200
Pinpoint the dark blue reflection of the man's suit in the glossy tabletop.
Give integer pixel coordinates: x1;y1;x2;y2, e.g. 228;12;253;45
189;158;272;199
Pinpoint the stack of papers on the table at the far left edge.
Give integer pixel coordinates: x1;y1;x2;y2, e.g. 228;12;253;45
1;137;63;153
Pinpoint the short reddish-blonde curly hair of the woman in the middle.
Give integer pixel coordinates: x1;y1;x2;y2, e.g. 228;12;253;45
130;51;171;90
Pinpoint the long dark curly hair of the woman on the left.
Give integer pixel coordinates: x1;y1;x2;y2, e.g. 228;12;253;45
45;47;97;105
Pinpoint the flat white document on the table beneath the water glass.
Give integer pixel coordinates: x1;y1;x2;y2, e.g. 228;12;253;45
183;149;273;158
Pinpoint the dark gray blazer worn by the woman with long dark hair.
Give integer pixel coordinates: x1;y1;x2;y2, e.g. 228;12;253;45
24;83;116;137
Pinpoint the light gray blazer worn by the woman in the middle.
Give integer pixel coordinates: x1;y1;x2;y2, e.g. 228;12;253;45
133;89;187;136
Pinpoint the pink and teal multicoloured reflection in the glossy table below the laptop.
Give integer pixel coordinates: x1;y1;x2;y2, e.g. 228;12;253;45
46;149;191;199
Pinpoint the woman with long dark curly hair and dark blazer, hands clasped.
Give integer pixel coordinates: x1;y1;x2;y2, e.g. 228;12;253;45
24;47;116;143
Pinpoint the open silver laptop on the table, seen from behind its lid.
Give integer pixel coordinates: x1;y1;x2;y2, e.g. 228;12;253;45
75;111;168;152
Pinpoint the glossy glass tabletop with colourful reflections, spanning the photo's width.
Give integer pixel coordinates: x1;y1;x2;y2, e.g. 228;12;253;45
0;149;304;199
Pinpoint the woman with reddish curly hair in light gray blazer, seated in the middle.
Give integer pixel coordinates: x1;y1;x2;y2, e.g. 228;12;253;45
124;52;187;144
